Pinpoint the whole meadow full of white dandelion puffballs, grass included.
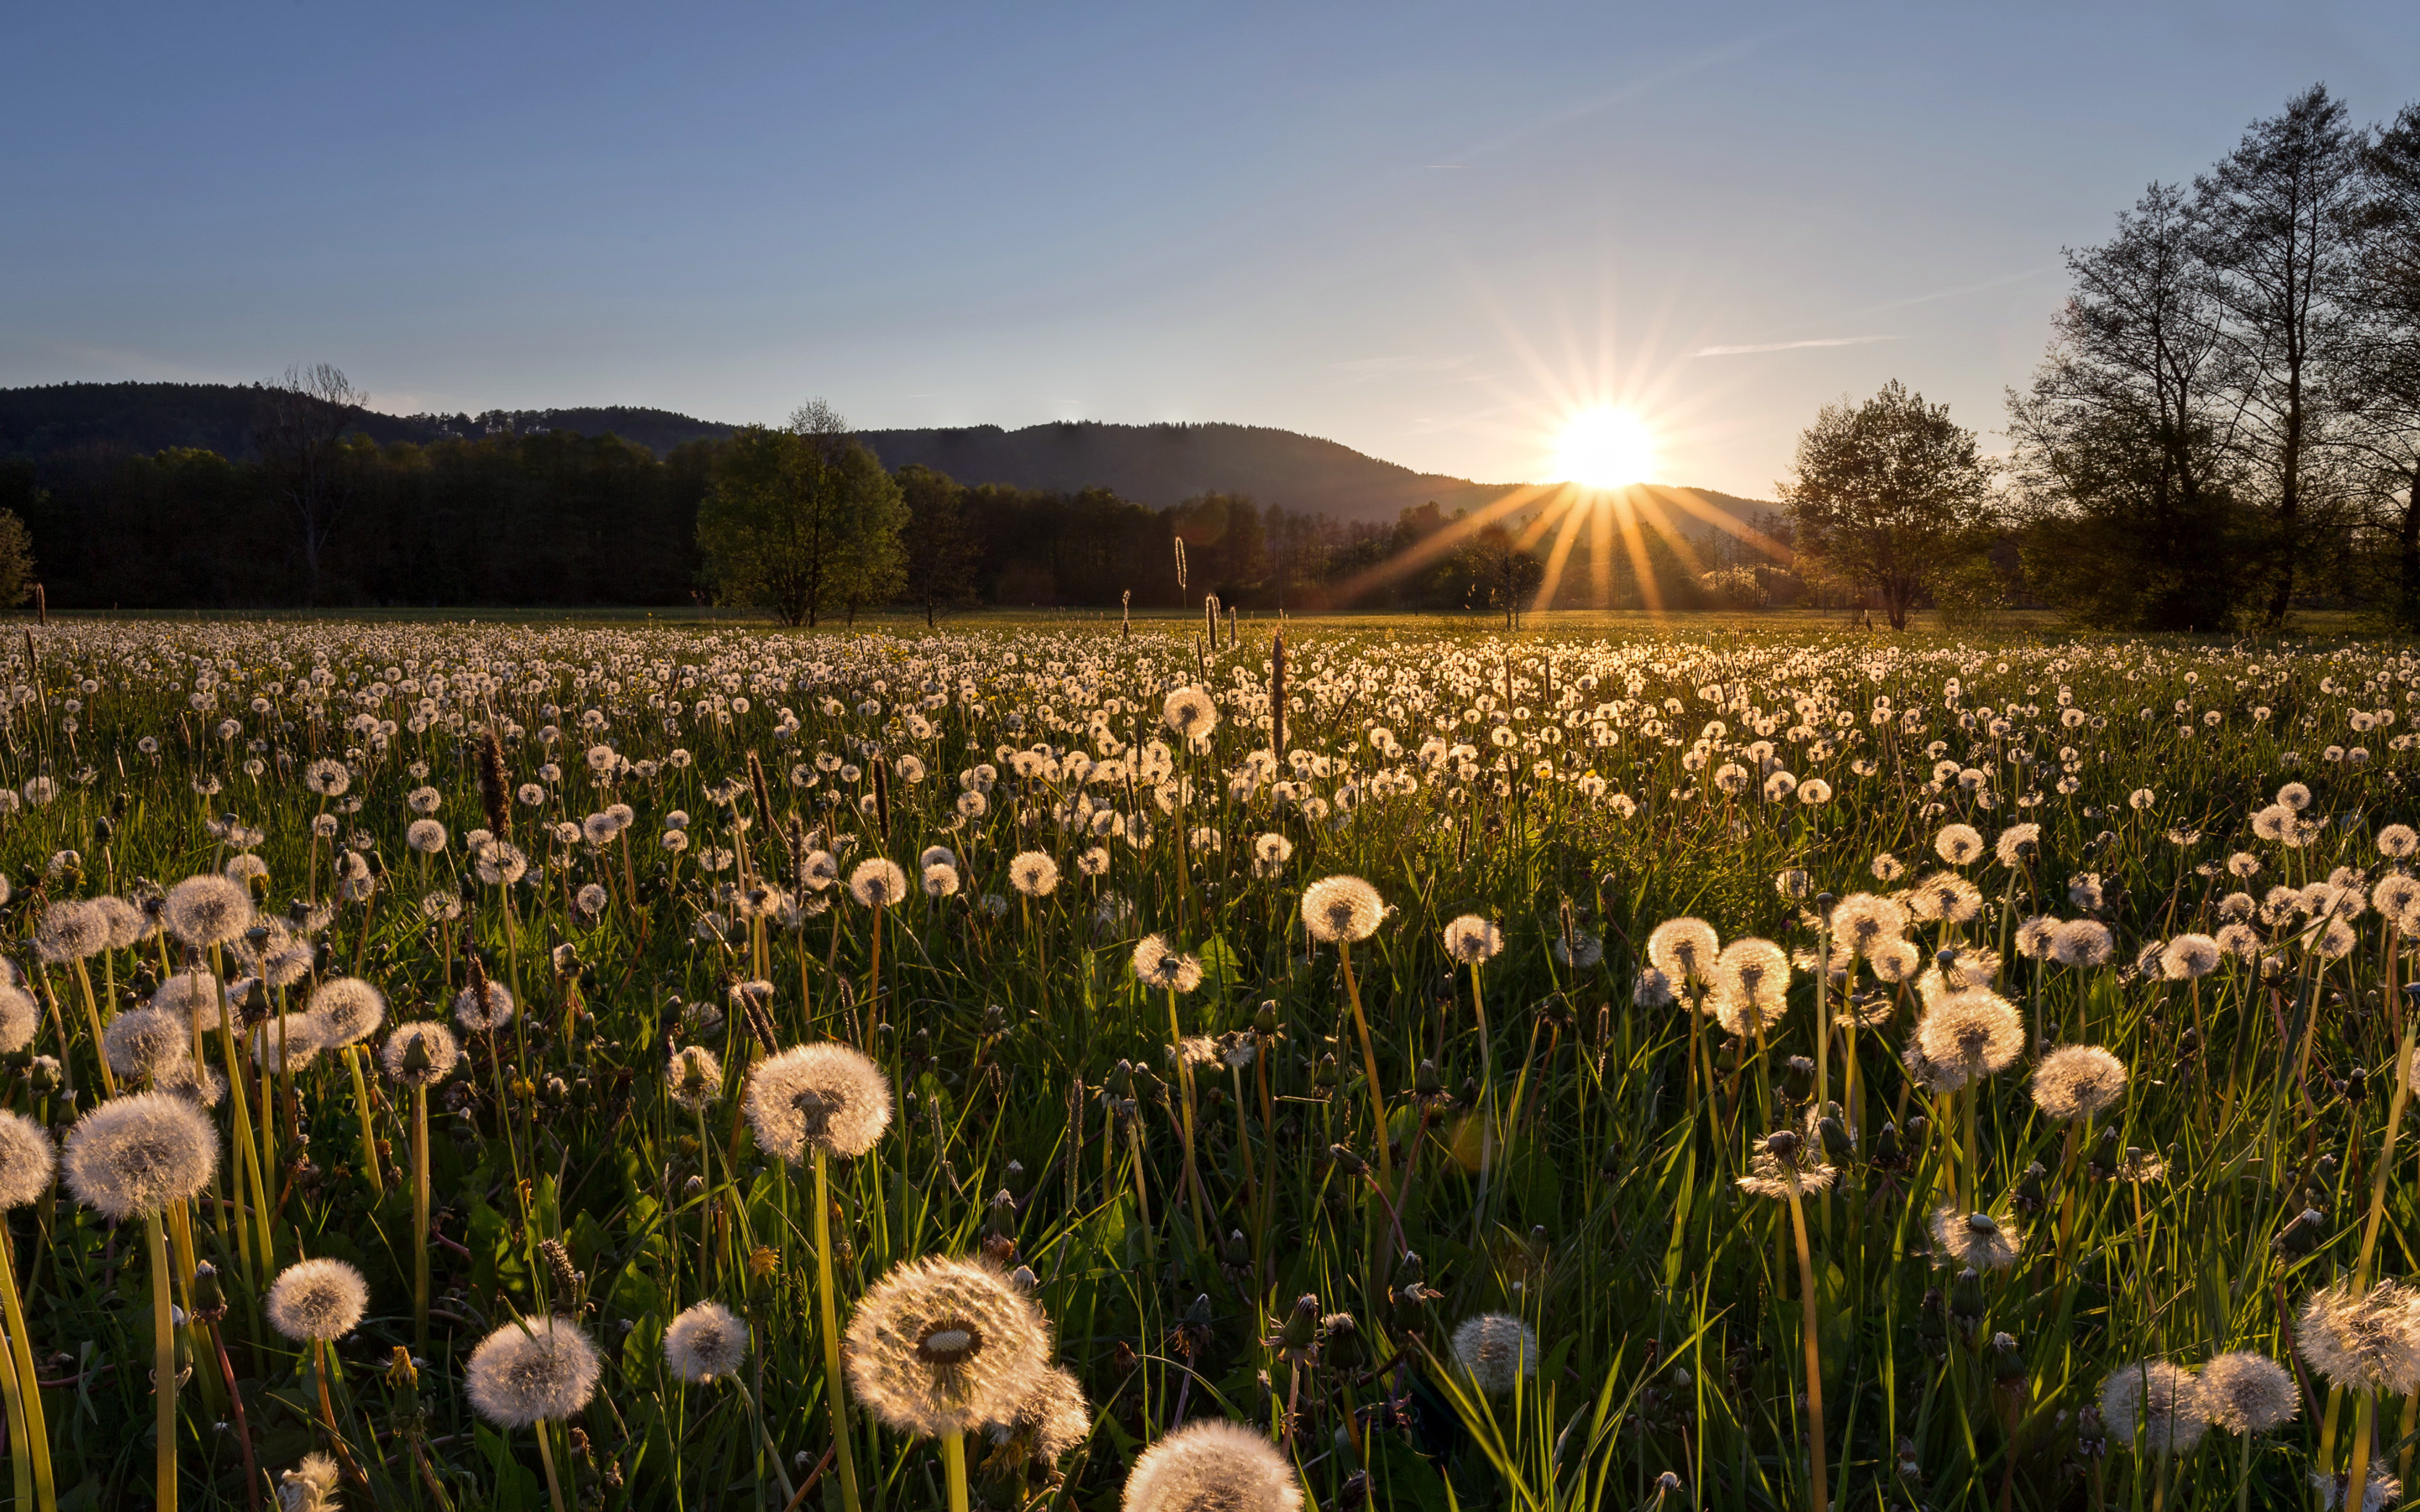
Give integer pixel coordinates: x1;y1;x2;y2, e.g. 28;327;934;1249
0;622;2420;1512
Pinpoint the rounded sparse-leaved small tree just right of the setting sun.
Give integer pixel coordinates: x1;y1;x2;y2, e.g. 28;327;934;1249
1779;380;1994;629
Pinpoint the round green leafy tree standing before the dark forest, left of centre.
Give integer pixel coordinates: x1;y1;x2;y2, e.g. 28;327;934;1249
697;399;908;627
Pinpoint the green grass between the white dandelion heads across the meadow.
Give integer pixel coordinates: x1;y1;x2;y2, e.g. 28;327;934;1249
0;612;2420;1509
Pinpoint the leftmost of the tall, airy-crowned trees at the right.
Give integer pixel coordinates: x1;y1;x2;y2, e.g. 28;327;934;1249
2008;184;2244;632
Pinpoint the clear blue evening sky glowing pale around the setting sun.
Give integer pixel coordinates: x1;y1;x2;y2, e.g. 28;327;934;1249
0;0;2420;498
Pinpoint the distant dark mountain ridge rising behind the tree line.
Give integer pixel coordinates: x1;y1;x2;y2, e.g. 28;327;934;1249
0;382;1779;522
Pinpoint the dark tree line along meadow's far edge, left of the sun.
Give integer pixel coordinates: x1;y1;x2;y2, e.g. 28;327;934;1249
0;377;1742;624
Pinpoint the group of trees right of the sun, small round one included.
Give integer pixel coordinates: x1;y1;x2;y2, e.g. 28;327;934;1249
1781;85;2420;632
